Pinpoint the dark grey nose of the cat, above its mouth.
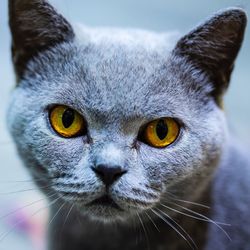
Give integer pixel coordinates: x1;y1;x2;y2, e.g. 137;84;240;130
92;164;127;186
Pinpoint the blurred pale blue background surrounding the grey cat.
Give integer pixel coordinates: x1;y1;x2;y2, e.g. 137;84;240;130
0;0;250;250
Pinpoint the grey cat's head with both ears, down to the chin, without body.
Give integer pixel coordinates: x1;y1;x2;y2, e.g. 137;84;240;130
8;0;246;221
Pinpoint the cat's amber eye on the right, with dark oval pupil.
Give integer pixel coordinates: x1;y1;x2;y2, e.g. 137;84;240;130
142;118;180;148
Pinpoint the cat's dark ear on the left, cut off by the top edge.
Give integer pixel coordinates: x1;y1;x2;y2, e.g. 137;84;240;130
9;0;74;79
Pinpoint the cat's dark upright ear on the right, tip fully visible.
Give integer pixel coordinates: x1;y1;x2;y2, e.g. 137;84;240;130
174;8;247;102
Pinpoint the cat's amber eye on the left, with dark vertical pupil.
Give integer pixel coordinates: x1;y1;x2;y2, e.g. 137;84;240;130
49;105;86;138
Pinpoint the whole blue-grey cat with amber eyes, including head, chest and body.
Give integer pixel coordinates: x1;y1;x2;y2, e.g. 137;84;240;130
7;0;250;250
